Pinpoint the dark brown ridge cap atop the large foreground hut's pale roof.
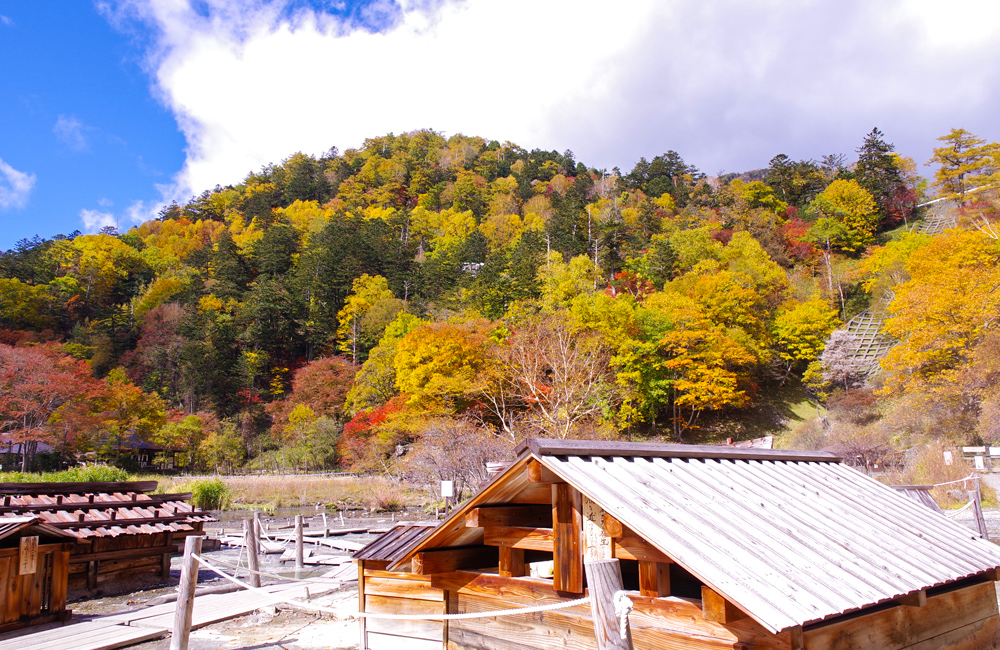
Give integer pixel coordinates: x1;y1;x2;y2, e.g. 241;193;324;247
515;438;843;463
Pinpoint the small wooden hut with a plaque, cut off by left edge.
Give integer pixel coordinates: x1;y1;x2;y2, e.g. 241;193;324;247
0;516;76;632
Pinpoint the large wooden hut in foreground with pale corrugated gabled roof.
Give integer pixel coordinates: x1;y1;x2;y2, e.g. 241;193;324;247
358;439;1000;650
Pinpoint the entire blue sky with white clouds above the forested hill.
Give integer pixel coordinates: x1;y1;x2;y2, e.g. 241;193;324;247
0;0;1000;250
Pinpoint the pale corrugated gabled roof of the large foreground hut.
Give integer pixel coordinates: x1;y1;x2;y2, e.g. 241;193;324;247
390;439;1000;632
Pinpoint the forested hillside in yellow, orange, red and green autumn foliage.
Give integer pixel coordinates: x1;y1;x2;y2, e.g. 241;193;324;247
0;129;1000;480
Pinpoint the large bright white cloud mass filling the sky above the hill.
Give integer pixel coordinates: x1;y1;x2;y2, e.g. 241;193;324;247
103;0;1000;195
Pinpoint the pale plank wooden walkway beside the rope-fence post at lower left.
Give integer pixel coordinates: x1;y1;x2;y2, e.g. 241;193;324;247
0;584;318;650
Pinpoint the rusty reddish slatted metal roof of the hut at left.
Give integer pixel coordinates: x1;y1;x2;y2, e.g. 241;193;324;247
0;481;215;540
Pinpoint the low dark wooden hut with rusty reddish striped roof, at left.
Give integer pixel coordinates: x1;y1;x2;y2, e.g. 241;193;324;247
0;481;214;593
